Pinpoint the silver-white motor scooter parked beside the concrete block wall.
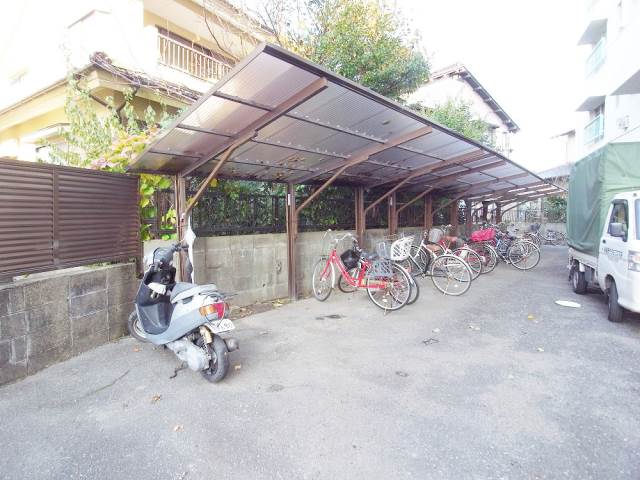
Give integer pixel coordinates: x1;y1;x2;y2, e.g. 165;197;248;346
128;243;238;382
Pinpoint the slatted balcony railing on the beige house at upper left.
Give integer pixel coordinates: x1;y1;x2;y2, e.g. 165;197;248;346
158;33;231;81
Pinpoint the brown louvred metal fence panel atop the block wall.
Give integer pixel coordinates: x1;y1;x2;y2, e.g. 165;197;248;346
0;160;141;279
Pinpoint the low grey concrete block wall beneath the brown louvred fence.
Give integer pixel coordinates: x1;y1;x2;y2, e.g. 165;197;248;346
0;264;138;385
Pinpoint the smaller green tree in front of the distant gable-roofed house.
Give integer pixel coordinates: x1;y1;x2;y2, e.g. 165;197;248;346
410;98;493;147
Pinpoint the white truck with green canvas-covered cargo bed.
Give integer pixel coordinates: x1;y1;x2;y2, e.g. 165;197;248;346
567;144;640;322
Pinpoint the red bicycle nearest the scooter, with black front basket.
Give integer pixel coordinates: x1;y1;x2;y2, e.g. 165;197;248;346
311;230;411;311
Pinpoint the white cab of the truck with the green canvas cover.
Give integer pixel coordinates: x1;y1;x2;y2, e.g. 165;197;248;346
597;191;640;321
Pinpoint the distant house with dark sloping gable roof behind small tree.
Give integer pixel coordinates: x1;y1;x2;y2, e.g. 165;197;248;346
407;63;520;156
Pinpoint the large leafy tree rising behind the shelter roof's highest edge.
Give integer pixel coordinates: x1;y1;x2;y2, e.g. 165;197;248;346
252;0;429;99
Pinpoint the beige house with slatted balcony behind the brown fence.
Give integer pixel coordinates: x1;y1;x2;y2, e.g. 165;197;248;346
0;0;271;160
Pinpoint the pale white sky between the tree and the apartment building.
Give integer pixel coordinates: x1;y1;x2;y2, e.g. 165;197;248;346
397;0;583;171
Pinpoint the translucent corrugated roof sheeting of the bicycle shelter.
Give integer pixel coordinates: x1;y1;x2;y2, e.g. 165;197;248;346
129;45;556;195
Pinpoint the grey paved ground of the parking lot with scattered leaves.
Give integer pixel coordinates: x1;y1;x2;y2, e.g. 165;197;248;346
0;247;640;480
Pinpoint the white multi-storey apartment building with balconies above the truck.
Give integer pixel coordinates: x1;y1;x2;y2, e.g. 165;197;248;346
572;0;640;161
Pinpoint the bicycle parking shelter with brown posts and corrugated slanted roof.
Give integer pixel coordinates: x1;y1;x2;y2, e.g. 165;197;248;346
129;43;564;299
